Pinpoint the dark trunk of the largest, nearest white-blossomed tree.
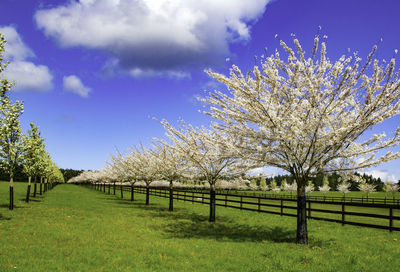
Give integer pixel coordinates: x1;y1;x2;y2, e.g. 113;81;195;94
296;183;308;245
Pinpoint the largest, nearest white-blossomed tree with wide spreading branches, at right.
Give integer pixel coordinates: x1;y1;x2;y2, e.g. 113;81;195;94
202;37;400;244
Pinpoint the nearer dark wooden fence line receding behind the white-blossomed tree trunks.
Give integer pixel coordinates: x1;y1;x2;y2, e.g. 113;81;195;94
90;184;400;231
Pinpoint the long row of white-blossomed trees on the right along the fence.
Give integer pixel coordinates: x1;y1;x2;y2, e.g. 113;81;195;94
70;36;400;244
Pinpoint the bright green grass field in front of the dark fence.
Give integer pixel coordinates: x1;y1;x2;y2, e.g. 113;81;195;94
0;182;400;271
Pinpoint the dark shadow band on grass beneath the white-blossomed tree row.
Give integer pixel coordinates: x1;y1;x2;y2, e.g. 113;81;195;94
97;193;331;247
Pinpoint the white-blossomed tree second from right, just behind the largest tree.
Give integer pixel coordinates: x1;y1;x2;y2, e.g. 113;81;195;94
161;120;248;222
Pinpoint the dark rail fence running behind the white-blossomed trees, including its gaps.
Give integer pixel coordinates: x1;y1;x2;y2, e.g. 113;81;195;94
90;184;400;231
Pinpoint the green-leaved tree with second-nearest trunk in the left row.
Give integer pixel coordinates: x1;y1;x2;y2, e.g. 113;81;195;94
22;123;44;202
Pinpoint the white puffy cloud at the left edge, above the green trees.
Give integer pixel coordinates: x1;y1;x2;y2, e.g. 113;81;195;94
0;26;53;91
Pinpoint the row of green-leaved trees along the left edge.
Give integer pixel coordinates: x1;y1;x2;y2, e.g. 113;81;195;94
0;34;64;210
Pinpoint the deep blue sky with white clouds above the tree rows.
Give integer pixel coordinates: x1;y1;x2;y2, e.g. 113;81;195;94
0;0;400;183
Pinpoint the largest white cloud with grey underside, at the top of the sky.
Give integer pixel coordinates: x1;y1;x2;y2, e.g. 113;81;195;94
35;0;270;76
